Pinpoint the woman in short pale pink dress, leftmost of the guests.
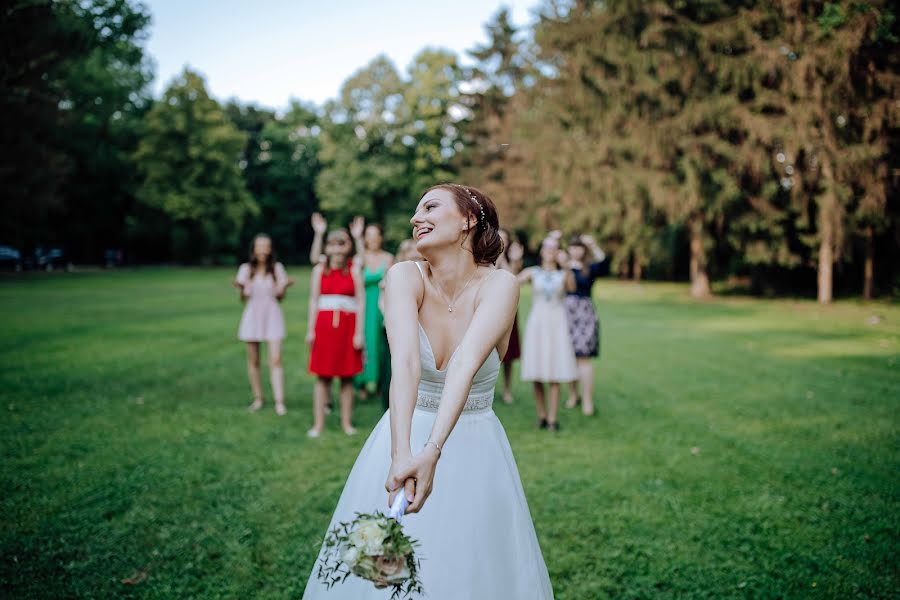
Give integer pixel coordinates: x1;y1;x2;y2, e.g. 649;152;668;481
232;234;294;415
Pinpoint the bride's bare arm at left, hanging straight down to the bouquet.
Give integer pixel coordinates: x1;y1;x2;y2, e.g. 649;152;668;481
384;262;424;502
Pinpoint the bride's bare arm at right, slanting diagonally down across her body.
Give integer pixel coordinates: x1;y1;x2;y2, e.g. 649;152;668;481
388;270;519;513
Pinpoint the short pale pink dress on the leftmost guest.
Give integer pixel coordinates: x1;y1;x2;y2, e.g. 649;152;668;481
235;263;287;342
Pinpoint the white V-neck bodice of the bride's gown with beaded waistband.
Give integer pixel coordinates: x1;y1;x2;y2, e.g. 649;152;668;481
416;325;500;412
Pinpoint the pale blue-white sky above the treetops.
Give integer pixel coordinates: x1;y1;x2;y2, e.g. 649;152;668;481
145;0;540;110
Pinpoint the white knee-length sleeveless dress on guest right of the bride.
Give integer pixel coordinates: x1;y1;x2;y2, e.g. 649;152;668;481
521;267;577;383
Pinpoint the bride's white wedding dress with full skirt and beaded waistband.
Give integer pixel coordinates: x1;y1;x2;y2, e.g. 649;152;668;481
303;325;553;600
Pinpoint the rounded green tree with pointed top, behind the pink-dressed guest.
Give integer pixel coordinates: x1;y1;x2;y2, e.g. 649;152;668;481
135;69;259;262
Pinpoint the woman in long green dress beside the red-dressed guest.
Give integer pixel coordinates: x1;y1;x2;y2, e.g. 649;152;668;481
356;223;394;400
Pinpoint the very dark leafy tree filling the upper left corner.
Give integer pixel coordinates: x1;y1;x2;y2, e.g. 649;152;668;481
0;0;151;260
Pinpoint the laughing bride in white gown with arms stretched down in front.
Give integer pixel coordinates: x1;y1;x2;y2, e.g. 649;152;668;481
303;184;553;600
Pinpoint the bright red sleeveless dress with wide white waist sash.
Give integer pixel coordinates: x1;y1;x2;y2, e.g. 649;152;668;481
309;267;362;377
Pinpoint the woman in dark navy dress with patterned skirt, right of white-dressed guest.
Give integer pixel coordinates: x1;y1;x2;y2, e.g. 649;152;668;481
565;235;608;415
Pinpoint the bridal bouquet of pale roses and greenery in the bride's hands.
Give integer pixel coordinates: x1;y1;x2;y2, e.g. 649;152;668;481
317;491;424;600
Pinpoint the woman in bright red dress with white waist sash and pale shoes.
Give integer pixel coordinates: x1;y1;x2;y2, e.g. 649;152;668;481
306;229;366;437
